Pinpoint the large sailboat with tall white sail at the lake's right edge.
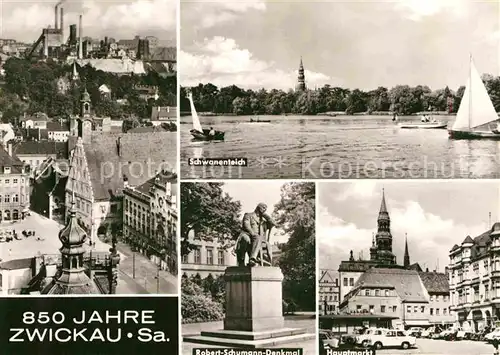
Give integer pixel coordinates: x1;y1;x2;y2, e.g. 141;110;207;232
448;56;500;139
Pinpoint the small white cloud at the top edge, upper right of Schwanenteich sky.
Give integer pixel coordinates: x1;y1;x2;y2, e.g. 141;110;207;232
396;0;467;21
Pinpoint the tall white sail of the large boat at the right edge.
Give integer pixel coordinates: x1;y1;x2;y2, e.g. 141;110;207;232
452;58;498;131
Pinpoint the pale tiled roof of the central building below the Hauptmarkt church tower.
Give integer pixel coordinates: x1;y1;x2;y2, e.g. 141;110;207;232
354;268;427;302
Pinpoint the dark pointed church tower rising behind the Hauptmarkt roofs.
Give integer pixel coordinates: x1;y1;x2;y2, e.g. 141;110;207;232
375;190;396;265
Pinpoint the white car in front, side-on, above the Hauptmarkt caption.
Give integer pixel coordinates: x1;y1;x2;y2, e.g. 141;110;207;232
356;328;416;349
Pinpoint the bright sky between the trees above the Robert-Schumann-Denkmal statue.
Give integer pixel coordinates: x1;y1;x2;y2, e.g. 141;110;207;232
222;180;288;244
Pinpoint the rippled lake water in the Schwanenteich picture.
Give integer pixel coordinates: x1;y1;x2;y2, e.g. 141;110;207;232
180;116;500;179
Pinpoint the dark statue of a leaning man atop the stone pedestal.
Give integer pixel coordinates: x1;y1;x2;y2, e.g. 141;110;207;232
235;203;276;266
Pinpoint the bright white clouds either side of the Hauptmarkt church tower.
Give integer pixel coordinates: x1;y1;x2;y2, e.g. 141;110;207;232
317;201;485;271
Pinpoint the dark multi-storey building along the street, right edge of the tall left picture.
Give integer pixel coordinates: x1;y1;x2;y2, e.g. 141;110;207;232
123;171;178;274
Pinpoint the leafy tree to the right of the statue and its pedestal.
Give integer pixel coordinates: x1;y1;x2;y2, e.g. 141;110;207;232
274;183;316;310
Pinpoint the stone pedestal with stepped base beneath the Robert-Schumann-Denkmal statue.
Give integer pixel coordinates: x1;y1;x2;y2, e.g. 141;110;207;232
184;266;316;349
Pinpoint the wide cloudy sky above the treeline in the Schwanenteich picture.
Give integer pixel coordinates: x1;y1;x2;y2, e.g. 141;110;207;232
179;0;500;90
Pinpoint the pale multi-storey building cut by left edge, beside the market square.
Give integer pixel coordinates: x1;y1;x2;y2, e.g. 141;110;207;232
0;144;30;221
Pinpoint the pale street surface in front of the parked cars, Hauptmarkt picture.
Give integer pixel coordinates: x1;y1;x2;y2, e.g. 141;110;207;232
377;339;495;355
